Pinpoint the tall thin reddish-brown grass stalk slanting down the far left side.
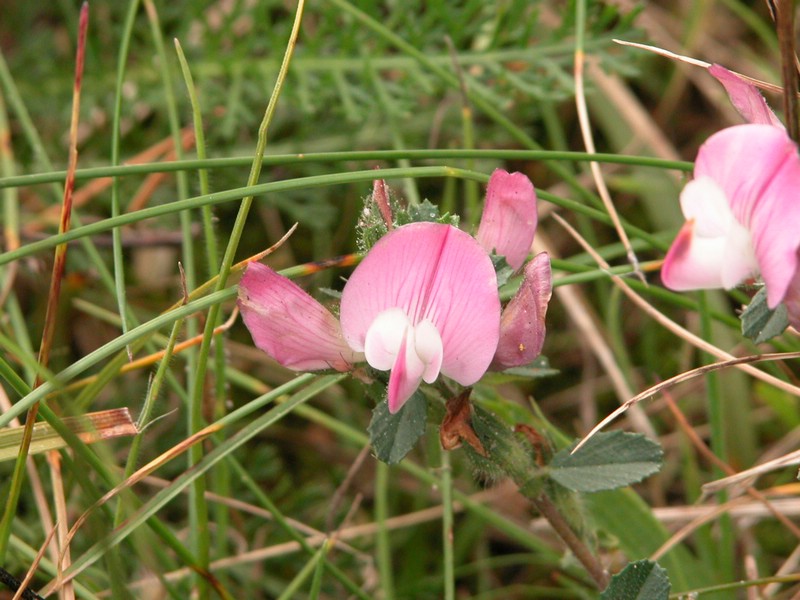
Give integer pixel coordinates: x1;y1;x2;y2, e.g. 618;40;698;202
0;2;89;557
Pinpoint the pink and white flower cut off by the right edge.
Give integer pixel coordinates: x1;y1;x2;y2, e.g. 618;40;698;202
661;124;800;325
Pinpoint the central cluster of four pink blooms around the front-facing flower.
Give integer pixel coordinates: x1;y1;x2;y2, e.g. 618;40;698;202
239;169;551;413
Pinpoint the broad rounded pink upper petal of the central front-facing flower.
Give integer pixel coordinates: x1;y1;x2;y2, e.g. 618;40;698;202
341;223;500;385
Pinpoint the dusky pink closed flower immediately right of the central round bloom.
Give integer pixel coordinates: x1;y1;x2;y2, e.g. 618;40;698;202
492;252;553;371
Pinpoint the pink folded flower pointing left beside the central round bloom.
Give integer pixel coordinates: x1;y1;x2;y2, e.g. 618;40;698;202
239;263;363;371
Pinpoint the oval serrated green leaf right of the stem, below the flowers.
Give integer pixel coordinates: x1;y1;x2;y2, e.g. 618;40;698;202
550;431;663;492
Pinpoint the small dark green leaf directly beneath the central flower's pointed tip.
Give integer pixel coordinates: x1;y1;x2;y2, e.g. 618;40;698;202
367;390;428;465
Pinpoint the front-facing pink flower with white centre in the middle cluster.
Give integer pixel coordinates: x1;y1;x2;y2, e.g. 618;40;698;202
340;223;500;412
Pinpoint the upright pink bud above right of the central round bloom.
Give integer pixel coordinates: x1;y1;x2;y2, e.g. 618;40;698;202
475;169;538;269
